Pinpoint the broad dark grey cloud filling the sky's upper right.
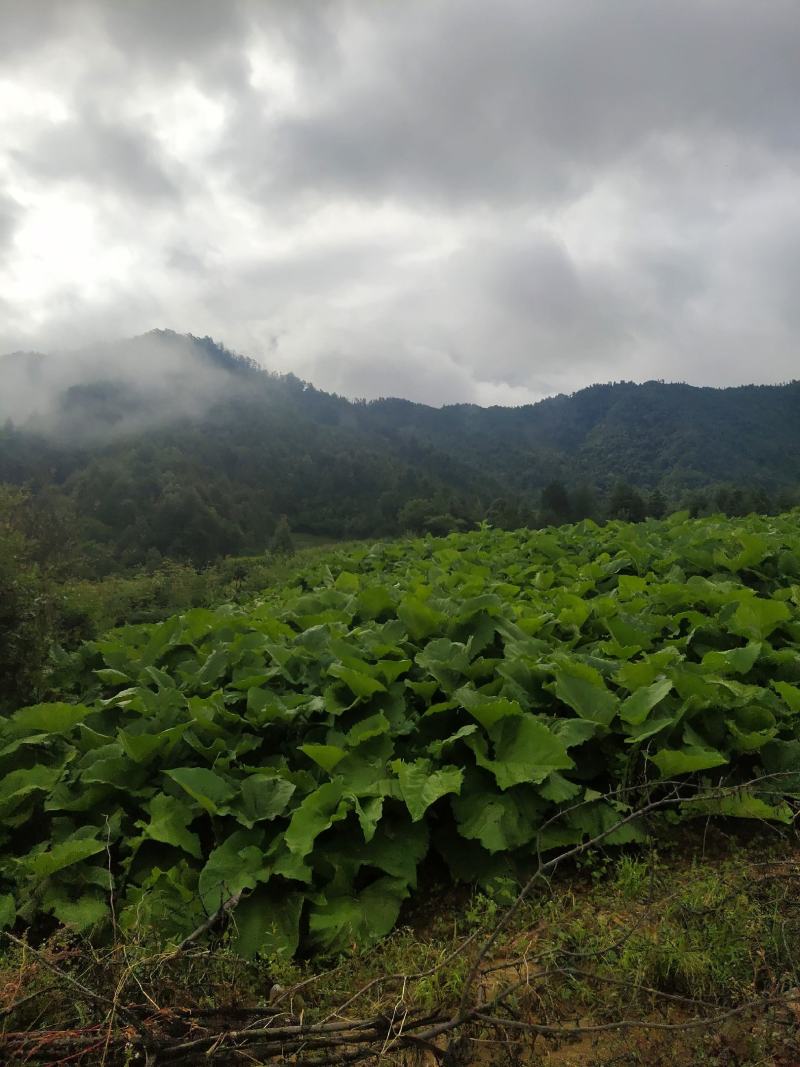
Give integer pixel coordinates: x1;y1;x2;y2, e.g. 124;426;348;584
253;0;800;204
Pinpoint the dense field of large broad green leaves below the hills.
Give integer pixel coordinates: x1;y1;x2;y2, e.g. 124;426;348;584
0;512;800;956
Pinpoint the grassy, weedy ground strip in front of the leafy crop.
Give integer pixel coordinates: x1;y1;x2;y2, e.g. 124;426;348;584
0;831;800;1067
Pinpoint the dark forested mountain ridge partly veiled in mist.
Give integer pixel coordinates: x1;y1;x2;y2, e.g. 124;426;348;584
0;331;800;573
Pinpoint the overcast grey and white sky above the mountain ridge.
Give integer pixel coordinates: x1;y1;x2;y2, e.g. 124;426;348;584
0;0;800;403
